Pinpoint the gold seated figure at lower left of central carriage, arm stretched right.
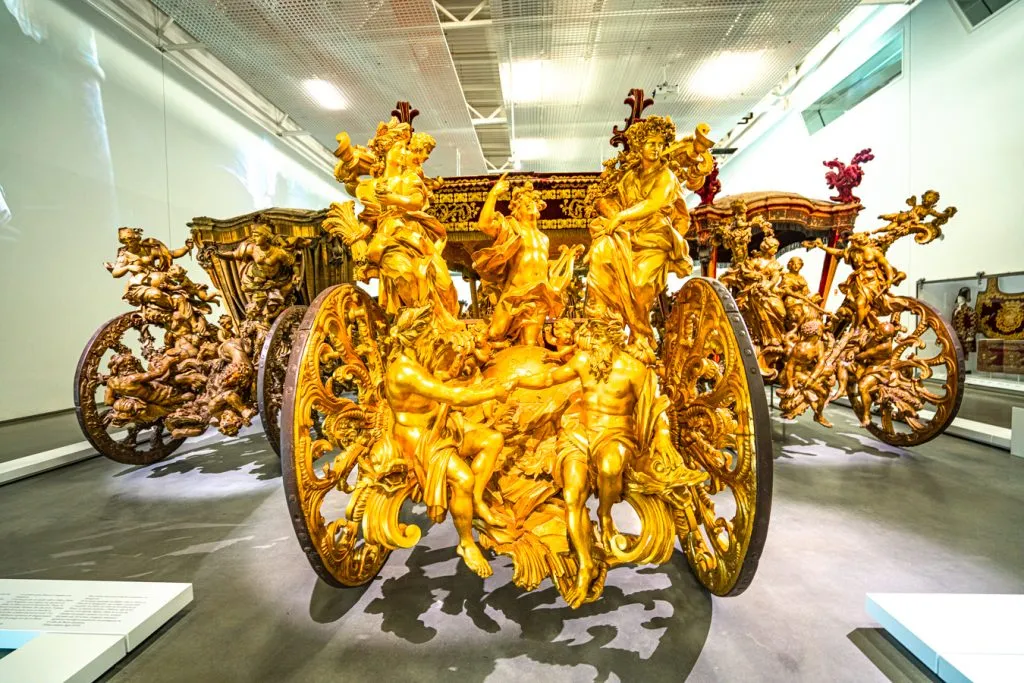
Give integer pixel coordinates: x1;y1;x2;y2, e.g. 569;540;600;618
384;305;512;578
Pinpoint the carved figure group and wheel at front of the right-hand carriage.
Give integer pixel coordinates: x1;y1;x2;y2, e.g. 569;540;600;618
712;190;963;445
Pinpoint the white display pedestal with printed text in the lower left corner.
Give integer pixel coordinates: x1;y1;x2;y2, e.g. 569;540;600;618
0;579;193;683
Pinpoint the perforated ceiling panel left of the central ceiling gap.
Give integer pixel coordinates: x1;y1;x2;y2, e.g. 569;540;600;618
146;0;484;175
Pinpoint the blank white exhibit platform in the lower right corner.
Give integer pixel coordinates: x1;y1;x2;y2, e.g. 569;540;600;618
866;593;1024;683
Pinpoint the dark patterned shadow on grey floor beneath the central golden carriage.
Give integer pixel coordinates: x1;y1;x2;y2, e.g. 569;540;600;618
299;546;712;682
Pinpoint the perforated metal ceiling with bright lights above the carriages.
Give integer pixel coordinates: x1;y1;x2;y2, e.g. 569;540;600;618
142;0;859;175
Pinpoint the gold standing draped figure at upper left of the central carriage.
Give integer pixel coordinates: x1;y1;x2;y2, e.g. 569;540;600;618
324;119;459;327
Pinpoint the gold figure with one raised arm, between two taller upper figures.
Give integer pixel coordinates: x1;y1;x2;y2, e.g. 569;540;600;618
473;175;584;345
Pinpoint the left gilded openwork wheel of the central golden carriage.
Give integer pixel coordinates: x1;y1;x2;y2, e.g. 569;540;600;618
281;285;401;587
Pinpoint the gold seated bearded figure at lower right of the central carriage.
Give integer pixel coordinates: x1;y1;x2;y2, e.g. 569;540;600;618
517;315;707;607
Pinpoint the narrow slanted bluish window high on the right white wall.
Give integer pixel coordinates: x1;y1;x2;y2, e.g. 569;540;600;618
803;31;903;135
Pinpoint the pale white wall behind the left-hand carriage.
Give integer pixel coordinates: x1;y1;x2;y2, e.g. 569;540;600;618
0;0;343;421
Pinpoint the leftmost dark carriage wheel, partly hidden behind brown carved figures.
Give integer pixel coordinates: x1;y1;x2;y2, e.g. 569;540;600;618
75;312;184;465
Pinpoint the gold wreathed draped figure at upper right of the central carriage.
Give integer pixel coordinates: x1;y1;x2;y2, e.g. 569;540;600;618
585;116;714;337
